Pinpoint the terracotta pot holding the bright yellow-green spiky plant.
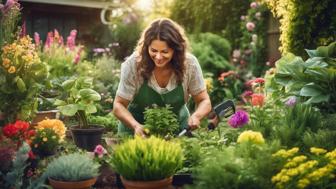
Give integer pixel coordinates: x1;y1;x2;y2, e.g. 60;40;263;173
121;176;173;189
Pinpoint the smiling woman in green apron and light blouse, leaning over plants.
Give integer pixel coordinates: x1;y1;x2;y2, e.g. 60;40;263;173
113;18;211;136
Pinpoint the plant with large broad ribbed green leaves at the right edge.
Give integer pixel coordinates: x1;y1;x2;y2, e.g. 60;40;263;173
271;42;336;113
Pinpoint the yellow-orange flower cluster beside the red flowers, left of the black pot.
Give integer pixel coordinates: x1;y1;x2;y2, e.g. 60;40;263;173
35;119;66;142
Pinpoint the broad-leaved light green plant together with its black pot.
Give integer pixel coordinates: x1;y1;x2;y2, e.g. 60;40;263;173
55;77;104;151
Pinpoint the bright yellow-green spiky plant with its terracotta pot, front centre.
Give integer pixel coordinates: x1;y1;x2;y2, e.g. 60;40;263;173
111;136;183;189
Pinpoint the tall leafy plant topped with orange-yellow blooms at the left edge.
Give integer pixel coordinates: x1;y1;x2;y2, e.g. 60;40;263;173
0;36;48;123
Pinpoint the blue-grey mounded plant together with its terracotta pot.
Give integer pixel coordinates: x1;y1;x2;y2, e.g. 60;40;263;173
45;153;99;189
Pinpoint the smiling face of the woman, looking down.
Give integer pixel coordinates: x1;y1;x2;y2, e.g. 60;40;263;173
148;39;174;68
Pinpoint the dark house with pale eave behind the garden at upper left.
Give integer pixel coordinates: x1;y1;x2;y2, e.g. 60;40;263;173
19;0;117;48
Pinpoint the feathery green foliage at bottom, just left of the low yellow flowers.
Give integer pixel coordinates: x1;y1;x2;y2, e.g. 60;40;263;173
188;142;279;189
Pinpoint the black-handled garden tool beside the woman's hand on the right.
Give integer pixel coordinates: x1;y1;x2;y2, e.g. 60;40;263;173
177;100;236;137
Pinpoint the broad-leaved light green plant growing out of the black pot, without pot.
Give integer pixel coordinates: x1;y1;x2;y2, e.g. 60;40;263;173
55;77;101;128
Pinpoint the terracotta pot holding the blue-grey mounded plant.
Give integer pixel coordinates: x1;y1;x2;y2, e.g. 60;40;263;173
48;177;97;189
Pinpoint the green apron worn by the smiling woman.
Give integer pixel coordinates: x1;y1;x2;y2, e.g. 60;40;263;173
118;81;190;135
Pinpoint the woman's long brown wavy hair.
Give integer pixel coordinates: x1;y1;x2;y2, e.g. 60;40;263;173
136;18;189;83
